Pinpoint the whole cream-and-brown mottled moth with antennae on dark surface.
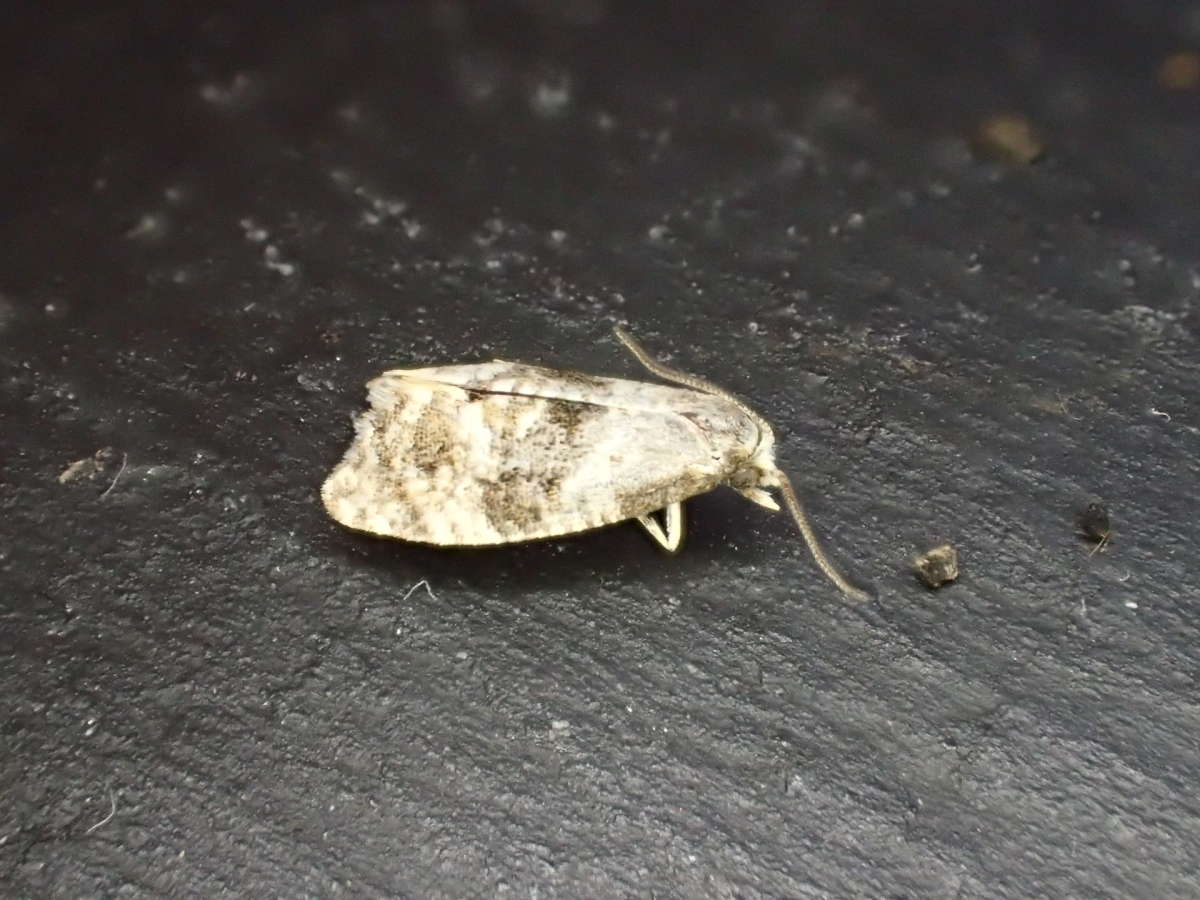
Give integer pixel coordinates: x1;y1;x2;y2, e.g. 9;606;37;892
320;328;866;599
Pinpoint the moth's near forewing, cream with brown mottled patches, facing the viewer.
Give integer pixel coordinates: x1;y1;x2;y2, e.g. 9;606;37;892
322;371;728;546
